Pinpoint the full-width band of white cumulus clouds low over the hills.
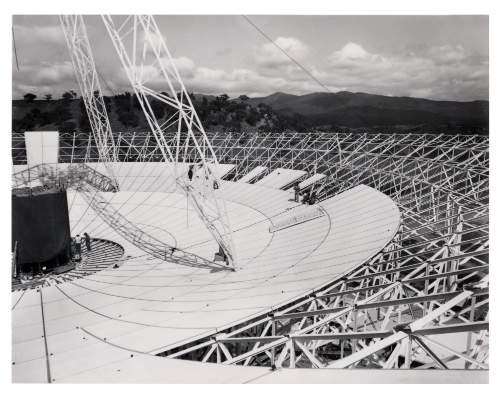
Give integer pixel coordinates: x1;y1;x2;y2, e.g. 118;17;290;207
13;27;489;100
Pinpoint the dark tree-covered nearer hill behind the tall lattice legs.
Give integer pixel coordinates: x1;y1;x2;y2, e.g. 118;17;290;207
12;90;311;132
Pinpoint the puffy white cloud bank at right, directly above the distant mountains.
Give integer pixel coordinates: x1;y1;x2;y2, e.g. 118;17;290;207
321;42;488;100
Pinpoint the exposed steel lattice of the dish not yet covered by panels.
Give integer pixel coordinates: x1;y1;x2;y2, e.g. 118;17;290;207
13;133;489;369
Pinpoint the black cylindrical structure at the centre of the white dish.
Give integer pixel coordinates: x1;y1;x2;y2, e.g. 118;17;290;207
12;190;71;272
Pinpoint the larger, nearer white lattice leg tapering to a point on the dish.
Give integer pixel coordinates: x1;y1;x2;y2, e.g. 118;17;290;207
102;15;237;267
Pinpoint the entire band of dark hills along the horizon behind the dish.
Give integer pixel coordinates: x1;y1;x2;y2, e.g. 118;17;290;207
12;92;489;134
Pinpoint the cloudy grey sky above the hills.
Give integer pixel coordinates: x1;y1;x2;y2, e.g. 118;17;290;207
12;15;489;101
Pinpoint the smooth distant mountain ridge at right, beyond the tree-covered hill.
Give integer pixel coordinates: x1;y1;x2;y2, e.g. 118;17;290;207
249;91;489;128
